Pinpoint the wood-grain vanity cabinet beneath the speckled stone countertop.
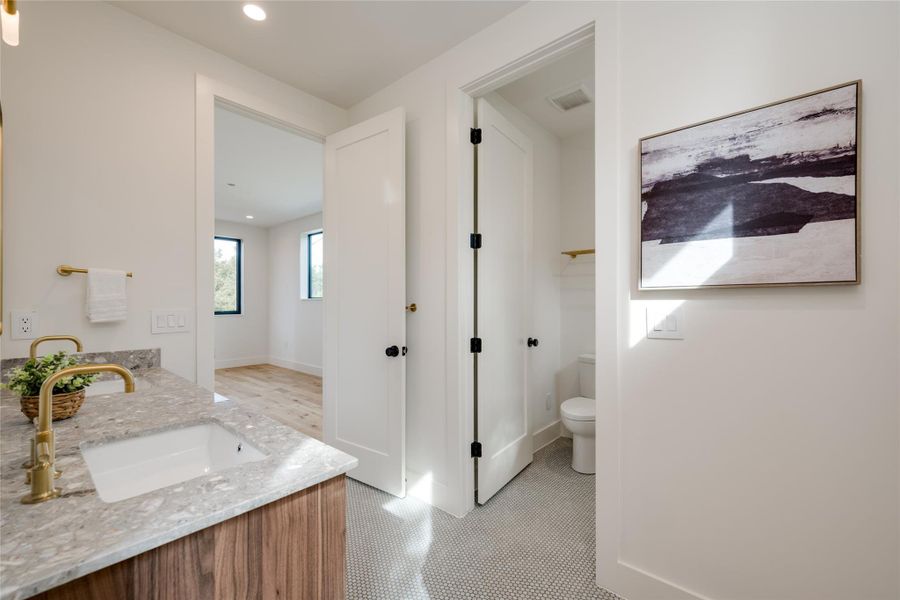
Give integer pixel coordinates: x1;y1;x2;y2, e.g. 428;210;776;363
34;475;346;600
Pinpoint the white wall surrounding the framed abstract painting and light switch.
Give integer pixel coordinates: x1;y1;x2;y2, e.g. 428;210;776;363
619;3;900;599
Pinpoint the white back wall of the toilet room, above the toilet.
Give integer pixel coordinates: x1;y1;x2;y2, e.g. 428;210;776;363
558;131;596;401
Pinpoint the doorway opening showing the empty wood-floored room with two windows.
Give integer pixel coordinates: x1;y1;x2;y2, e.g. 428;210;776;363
213;103;325;439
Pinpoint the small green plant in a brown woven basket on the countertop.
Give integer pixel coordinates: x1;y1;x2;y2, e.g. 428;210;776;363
6;350;97;421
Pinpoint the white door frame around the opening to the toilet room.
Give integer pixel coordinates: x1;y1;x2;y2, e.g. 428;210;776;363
446;17;705;600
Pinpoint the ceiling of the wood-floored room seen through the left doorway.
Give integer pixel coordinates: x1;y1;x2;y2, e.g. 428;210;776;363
215;105;324;227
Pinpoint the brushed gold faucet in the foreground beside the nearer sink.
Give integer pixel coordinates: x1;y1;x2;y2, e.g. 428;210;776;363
22;364;134;504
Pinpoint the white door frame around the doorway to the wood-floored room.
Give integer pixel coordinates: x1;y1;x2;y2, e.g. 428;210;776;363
194;74;336;391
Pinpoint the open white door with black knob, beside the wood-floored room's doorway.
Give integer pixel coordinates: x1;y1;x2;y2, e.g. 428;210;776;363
322;108;406;496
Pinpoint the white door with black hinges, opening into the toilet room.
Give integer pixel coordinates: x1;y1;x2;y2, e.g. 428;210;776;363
475;98;534;504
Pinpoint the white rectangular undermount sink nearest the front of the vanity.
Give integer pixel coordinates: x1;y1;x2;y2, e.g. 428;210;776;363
81;422;266;502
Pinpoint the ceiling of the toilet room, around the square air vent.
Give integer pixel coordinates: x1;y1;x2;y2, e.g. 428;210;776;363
497;45;594;138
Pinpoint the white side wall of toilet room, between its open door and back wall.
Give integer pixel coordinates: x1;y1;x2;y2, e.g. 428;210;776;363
486;93;561;442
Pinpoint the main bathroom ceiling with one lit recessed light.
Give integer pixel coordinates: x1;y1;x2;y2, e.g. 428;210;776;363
112;0;524;108
